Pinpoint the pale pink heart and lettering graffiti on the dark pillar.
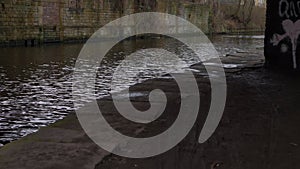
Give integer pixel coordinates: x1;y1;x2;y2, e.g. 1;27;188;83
271;0;300;69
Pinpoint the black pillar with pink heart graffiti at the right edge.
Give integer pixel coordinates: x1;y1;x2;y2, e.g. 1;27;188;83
265;0;300;70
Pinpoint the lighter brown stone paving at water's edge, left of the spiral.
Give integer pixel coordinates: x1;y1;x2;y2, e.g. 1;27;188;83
0;114;108;169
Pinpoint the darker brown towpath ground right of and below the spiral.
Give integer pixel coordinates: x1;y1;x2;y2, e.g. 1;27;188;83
96;68;300;169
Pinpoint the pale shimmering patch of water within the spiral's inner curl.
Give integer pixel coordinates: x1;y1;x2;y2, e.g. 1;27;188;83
111;48;189;92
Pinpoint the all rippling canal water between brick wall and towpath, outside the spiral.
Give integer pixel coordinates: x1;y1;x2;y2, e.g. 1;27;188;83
0;35;264;147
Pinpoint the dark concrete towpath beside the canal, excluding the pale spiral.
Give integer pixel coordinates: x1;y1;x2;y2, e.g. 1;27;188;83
0;53;300;169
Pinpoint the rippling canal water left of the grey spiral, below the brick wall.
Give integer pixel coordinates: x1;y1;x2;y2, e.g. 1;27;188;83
0;45;82;144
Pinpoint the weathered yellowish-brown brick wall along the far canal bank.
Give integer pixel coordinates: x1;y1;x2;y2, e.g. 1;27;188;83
0;0;209;45
